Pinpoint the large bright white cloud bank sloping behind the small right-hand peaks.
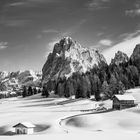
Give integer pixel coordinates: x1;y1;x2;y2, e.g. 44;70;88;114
103;32;140;63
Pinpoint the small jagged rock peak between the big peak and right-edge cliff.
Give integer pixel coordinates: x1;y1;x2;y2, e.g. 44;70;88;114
111;51;129;65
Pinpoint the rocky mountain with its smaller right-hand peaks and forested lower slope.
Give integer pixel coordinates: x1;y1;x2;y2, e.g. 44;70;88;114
42;37;140;100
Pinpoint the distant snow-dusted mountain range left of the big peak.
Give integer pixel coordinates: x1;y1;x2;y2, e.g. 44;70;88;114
0;70;42;91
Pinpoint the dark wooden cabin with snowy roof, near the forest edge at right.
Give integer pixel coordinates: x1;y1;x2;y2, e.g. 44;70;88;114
113;95;135;110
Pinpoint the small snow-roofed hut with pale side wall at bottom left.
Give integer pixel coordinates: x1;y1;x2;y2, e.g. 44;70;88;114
13;122;35;134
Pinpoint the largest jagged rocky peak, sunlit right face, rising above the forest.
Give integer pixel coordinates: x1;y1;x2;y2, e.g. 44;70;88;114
42;37;106;84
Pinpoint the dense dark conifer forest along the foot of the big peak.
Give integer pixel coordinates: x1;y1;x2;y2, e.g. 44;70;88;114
43;59;140;101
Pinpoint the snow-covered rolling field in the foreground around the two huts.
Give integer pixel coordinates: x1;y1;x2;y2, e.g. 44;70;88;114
0;88;140;140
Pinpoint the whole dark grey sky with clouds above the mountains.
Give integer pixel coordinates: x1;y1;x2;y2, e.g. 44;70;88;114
0;0;140;71
